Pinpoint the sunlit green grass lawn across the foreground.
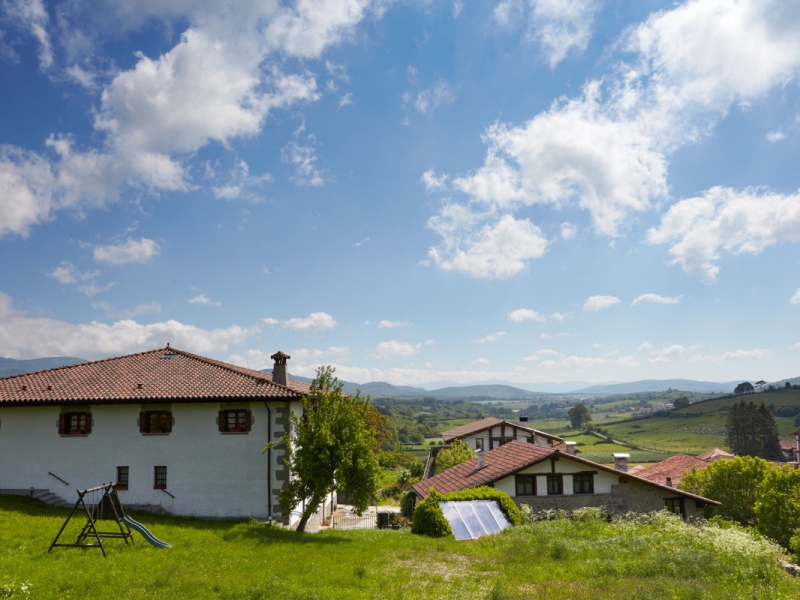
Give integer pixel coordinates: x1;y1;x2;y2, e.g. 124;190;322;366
0;497;800;600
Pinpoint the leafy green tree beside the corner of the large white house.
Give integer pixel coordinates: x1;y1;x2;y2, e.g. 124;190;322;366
264;367;379;531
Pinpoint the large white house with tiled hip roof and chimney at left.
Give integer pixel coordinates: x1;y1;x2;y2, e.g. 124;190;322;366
0;345;326;523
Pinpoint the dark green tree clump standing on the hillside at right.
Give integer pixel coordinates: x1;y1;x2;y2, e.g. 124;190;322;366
725;400;781;460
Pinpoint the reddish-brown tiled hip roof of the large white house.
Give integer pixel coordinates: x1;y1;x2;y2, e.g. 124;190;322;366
0;345;308;406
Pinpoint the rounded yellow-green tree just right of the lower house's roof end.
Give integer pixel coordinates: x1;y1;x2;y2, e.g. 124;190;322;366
678;456;777;525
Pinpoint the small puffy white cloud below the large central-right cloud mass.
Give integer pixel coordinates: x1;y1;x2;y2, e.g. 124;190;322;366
428;211;547;279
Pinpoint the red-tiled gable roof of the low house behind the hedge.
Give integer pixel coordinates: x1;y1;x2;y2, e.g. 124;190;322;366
412;440;720;506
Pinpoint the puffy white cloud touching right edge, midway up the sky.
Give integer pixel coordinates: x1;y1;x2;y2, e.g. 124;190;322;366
647;187;800;281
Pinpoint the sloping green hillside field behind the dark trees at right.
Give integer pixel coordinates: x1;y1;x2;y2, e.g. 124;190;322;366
604;390;800;454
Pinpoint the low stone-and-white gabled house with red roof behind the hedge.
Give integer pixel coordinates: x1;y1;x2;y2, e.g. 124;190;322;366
413;441;720;519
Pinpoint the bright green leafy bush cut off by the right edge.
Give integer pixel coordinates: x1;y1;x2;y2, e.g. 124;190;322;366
755;465;800;548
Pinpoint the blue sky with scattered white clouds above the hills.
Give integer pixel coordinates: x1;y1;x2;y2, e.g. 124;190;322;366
0;0;800;389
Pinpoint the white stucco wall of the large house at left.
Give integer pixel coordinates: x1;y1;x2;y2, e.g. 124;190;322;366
0;402;302;518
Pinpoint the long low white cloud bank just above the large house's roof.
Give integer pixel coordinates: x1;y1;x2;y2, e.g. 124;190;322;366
0;292;258;359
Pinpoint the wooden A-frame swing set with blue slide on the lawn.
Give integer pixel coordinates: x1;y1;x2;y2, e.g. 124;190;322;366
48;483;171;556
